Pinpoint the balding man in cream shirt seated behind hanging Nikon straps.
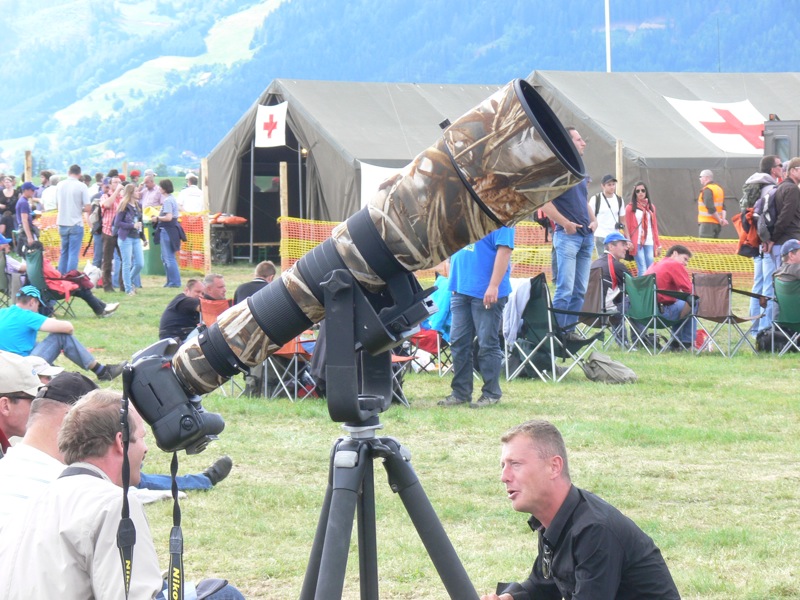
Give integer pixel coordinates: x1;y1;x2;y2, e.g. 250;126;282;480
0;390;243;600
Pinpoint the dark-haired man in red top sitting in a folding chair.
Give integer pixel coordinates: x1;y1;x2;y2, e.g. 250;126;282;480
645;245;694;350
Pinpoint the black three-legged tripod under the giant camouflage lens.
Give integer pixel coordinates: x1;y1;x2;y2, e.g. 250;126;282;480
300;416;478;600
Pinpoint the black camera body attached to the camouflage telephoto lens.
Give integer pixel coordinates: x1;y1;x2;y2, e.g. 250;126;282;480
129;339;225;454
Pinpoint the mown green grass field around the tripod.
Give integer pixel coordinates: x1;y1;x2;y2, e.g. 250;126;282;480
53;266;800;600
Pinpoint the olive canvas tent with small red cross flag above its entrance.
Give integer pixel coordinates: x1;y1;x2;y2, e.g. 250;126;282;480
208;79;498;221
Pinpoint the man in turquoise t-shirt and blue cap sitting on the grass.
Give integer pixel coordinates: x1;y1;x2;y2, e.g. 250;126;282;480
0;285;125;381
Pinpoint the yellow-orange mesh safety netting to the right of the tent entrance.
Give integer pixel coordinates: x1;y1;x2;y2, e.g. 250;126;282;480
280;217;753;288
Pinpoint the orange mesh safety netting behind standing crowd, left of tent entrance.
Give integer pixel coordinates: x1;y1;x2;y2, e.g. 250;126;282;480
34;211;211;273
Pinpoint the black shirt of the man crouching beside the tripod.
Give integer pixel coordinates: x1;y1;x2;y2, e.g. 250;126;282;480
504;486;680;600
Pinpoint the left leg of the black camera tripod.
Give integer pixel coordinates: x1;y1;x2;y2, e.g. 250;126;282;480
314;440;371;600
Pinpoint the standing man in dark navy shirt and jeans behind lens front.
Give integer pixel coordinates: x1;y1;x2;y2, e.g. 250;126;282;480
542;127;597;338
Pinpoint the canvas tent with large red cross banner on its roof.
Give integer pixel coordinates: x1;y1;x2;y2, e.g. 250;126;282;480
528;71;800;237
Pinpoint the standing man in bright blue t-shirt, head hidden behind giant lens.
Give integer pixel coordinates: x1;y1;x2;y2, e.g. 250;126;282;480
439;227;514;408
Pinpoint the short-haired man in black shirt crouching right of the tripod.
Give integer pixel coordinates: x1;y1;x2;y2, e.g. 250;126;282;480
481;421;680;600
